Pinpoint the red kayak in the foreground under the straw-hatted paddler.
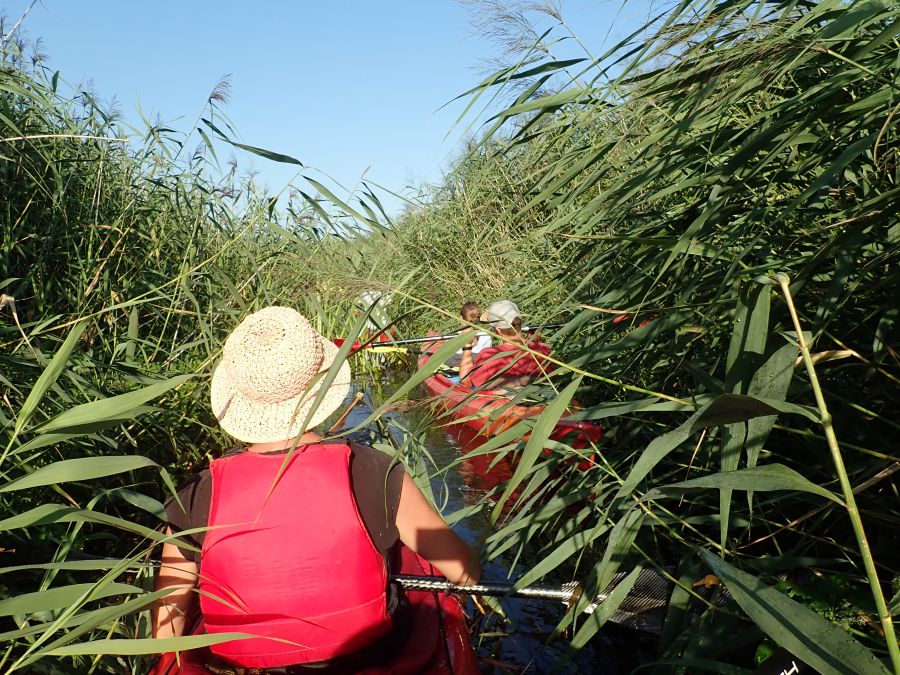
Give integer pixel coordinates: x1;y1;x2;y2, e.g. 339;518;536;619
150;547;481;675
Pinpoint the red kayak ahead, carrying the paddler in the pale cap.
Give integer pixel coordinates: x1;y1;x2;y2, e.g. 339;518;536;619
419;333;603;449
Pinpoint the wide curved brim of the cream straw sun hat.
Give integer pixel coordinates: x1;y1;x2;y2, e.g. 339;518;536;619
210;336;351;443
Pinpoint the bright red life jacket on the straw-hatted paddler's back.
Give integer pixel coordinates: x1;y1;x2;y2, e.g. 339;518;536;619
198;444;392;668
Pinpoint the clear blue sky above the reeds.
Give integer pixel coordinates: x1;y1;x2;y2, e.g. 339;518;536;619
0;0;648;211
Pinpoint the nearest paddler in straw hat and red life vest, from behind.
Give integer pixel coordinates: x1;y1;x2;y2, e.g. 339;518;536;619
152;307;481;673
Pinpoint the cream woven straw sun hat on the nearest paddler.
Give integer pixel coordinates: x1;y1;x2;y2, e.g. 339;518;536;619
210;307;350;443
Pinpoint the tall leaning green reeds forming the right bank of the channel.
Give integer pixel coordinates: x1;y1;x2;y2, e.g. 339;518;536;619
332;0;900;670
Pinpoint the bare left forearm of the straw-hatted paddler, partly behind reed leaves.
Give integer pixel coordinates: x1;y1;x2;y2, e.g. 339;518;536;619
152;529;197;638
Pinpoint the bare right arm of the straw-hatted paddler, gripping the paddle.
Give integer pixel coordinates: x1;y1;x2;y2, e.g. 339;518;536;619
397;474;481;584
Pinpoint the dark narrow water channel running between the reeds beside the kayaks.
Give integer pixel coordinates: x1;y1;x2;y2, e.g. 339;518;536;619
346;371;652;675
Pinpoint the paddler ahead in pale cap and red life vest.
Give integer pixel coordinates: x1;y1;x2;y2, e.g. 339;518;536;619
459;300;550;390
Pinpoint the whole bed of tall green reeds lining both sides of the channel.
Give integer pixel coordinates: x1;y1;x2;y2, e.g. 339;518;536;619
0;0;900;673
